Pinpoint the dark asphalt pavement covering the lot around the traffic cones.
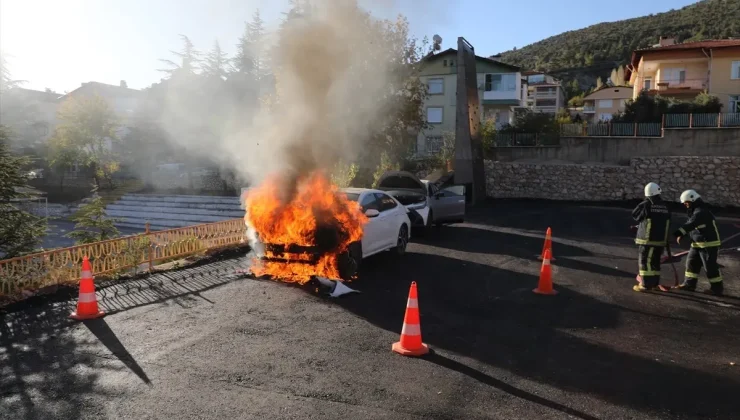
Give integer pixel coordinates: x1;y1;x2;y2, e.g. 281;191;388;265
0;201;740;420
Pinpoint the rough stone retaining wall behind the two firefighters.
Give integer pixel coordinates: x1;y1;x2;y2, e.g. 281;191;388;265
486;156;740;206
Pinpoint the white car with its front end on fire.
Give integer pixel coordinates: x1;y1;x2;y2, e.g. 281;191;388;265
247;188;411;280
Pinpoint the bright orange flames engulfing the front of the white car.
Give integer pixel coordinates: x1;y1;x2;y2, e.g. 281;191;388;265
244;171;367;284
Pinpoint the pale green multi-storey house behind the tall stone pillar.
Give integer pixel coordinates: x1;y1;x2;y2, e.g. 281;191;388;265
416;48;526;155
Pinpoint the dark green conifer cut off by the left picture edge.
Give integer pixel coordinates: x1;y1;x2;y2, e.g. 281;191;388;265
0;126;46;258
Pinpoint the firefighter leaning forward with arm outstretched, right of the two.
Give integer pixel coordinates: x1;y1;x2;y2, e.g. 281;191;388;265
673;190;724;296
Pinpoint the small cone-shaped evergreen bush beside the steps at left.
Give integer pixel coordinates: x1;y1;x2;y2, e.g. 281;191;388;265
65;188;121;245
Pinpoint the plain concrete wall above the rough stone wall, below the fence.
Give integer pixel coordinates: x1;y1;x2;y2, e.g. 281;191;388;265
496;128;740;165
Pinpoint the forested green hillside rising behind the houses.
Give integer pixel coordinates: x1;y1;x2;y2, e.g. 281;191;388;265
500;0;740;84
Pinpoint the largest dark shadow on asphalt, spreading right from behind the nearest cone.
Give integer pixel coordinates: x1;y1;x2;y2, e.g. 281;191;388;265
337;246;740;418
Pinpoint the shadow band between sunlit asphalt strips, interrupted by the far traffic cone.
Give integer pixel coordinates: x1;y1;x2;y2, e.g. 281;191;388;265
413;226;637;277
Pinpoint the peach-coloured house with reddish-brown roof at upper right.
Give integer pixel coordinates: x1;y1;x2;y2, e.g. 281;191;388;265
625;38;740;112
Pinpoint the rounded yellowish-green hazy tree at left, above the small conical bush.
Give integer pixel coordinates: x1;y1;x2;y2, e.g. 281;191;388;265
49;95;119;188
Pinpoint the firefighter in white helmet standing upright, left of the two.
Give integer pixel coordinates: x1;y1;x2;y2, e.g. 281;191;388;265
632;182;671;292
